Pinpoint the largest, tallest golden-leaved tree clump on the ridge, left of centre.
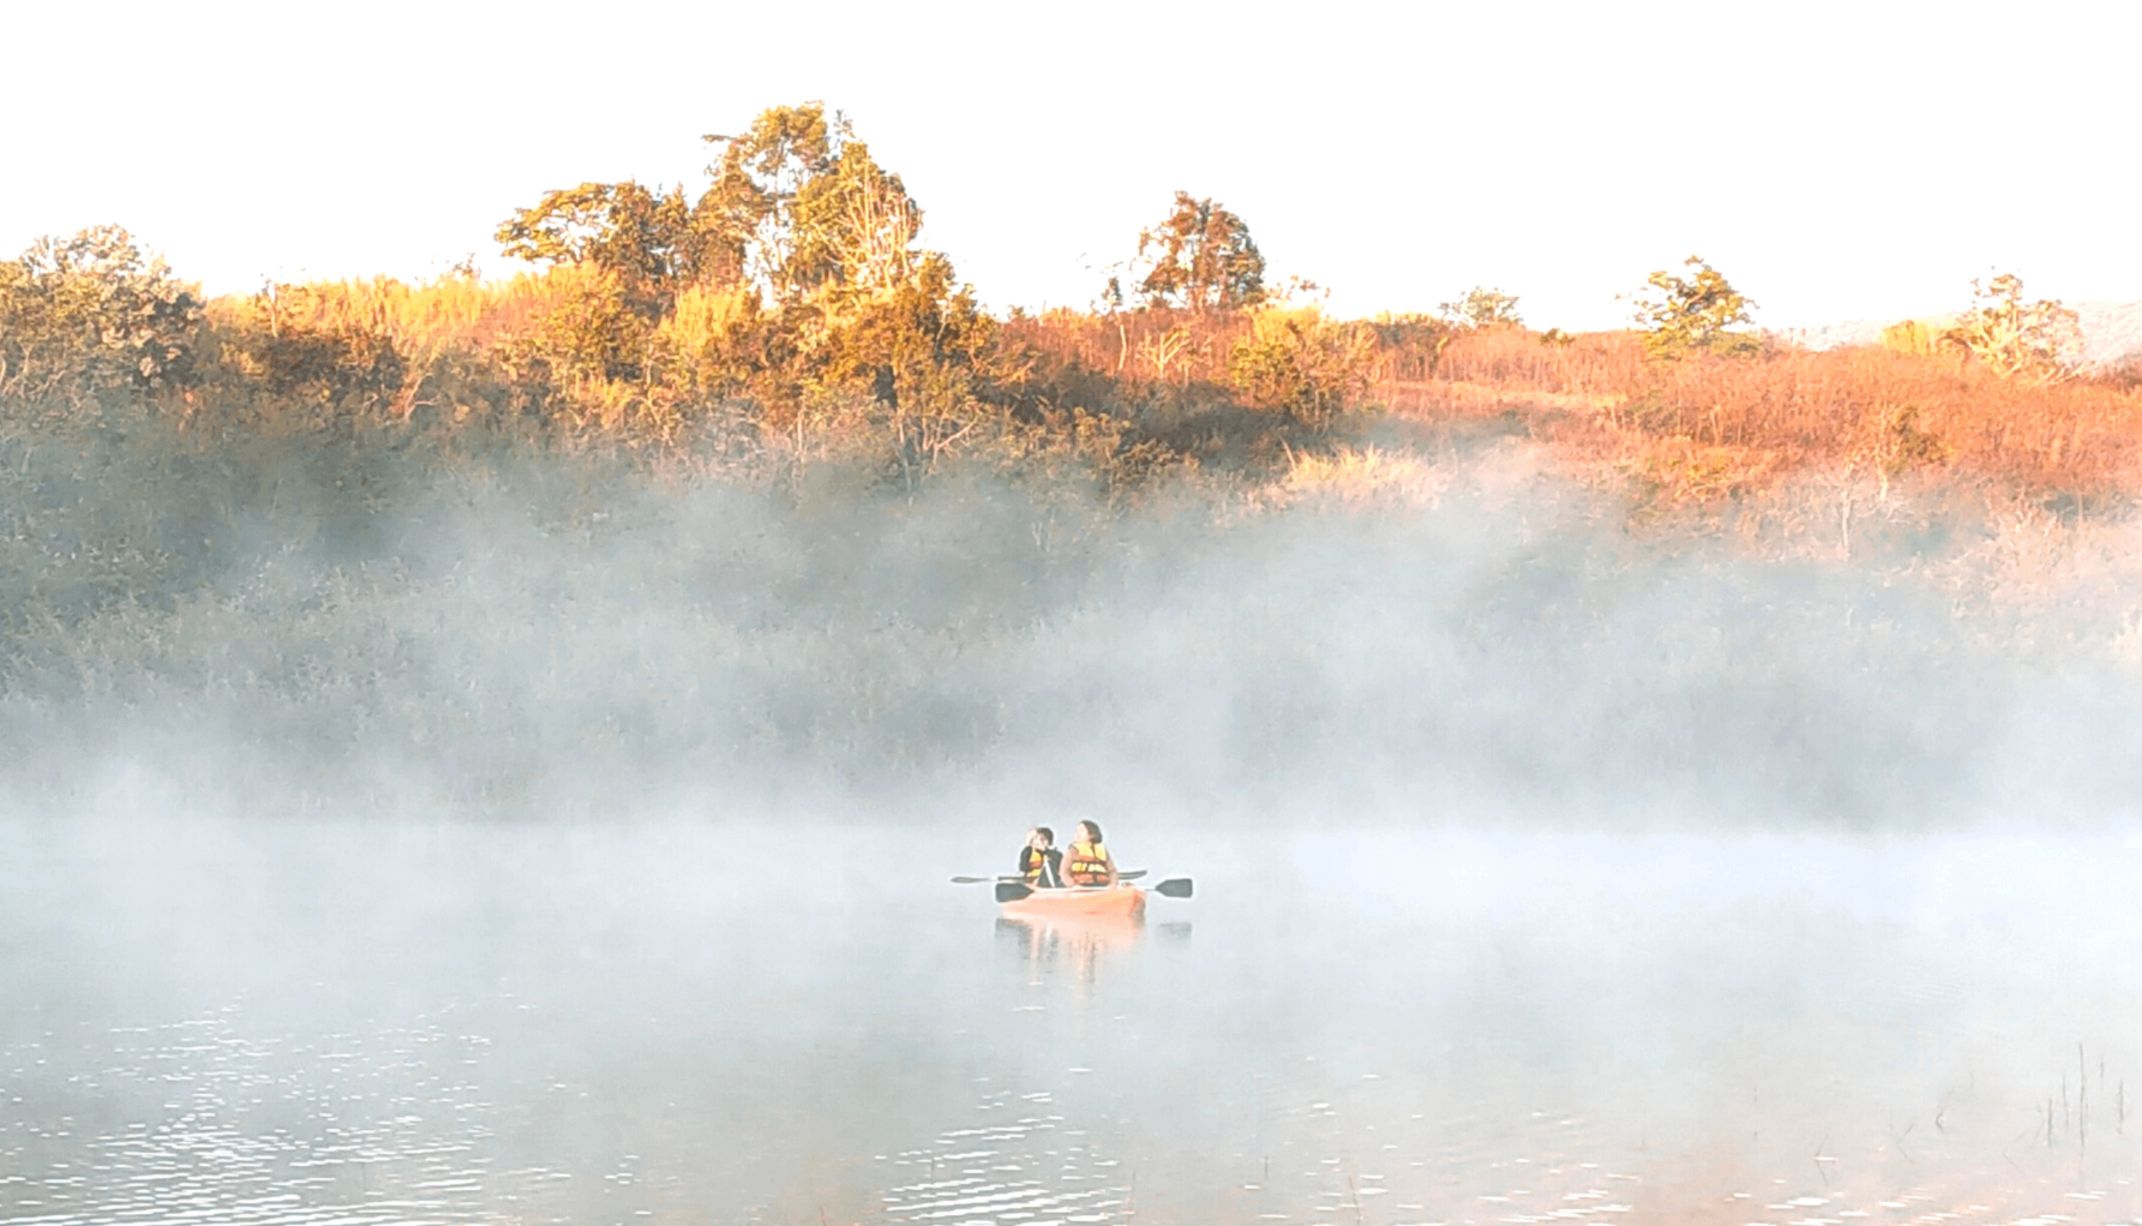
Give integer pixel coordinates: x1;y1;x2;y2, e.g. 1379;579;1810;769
499;103;992;458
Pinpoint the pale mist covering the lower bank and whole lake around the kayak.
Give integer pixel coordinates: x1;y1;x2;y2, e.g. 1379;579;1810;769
0;432;2142;1224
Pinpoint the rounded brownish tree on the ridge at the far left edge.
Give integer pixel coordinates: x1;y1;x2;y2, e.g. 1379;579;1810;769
0;225;201;399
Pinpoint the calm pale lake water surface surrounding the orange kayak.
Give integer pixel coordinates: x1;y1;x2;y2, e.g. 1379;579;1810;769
0;821;2142;1226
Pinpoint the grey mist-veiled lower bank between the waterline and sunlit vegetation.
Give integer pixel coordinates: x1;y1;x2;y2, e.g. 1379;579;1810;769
0;407;2136;827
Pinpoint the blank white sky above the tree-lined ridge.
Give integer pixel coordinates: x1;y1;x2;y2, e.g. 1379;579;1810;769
0;0;2142;328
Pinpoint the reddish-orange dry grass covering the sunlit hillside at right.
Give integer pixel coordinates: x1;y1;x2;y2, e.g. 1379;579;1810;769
1379;323;2142;504
